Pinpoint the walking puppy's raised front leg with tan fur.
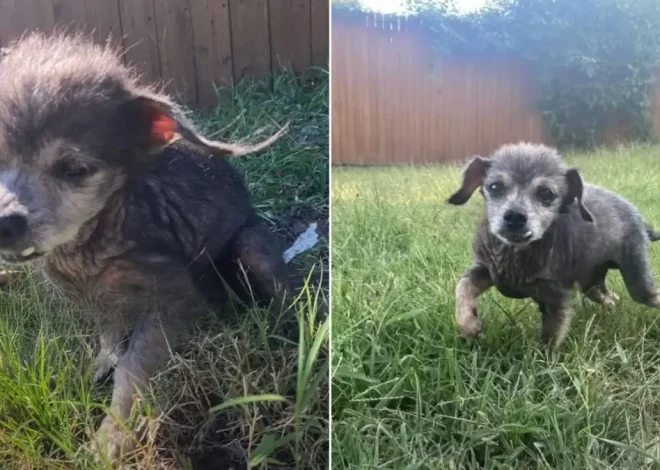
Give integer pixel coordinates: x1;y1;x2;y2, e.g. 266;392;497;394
456;265;493;338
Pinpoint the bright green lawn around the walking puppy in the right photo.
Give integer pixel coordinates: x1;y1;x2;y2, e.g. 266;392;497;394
331;146;660;469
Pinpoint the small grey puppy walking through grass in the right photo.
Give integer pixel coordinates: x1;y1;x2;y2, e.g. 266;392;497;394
448;143;660;347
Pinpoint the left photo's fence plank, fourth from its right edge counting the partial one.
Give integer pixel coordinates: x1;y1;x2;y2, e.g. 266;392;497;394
190;0;233;107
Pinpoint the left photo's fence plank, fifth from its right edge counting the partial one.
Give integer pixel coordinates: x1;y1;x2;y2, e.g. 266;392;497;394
154;0;197;105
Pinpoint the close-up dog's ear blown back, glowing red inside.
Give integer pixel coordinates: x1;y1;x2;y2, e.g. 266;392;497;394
136;93;289;156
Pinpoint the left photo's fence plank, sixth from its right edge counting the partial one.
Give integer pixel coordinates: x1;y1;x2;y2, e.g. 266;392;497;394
119;0;160;82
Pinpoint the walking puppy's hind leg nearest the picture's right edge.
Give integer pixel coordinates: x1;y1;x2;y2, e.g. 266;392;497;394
619;240;660;308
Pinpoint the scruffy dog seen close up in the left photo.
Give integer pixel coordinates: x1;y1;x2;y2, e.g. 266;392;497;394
0;34;288;459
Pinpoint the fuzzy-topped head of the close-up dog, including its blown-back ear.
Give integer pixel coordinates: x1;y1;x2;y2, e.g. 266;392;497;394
0;34;281;262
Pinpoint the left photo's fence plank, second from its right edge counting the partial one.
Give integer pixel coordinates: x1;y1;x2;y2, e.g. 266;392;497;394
268;0;312;73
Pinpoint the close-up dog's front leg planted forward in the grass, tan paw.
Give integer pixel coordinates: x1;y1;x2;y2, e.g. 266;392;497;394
94;258;204;462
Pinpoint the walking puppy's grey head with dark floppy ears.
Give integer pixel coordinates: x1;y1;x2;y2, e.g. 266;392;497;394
449;143;593;245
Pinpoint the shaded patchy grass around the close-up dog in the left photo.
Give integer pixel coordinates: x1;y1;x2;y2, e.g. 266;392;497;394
0;73;329;469
